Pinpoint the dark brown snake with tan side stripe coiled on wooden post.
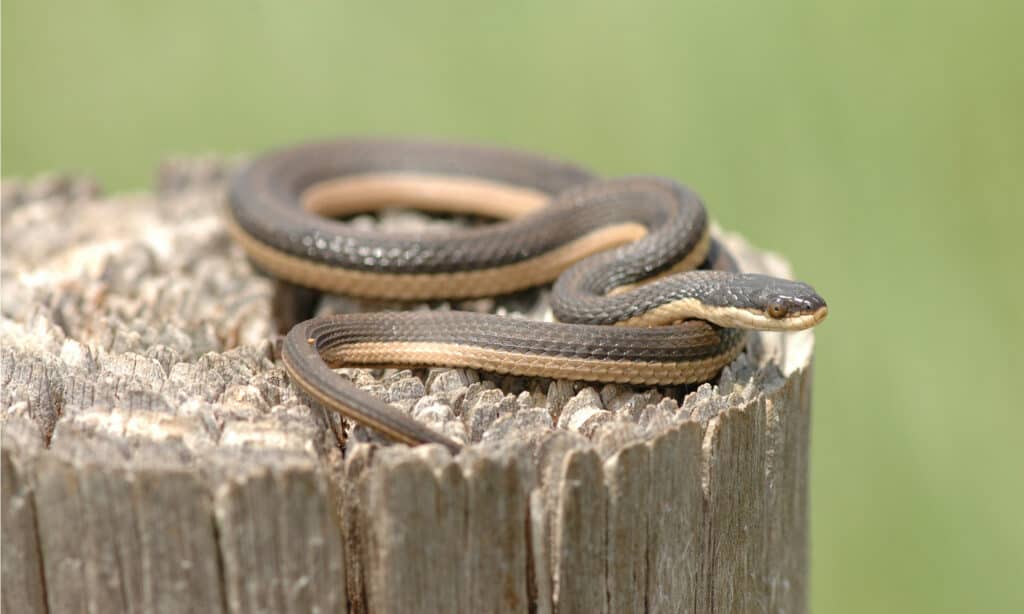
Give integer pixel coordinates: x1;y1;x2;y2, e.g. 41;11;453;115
226;139;827;452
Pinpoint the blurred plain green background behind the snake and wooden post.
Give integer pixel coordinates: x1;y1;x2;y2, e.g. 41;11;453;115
2;0;1024;613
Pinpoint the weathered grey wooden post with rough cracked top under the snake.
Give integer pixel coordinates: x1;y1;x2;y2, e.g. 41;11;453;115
0;159;813;614
